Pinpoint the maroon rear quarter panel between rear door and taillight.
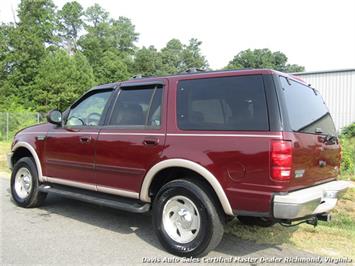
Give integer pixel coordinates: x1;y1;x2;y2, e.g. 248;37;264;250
163;73;285;215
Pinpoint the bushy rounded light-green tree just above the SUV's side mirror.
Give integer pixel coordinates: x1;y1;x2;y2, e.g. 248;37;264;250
31;49;94;111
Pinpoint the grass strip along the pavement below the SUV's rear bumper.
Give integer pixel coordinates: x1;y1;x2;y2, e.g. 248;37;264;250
225;188;355;260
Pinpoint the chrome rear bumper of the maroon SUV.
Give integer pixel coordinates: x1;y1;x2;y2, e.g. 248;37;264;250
273;181;350;220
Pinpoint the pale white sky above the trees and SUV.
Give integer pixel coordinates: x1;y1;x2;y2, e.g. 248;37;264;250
0;0;355;71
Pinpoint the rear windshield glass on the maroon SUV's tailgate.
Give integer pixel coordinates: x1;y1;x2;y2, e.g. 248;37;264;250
280;77;335;135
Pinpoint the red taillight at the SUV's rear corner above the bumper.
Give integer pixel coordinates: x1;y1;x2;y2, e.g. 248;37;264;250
270;140;292;181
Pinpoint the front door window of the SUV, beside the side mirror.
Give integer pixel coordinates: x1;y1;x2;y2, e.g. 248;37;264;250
66;90;112;126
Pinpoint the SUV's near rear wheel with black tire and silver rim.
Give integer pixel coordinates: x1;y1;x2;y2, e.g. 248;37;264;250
153;179;224;257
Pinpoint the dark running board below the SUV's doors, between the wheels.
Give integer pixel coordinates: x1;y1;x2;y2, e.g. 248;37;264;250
38;184;150;213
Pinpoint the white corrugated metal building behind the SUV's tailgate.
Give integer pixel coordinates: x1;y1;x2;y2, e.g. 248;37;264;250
294;69;355;130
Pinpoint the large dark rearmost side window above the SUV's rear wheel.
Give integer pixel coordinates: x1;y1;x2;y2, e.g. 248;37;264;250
177;75;269;130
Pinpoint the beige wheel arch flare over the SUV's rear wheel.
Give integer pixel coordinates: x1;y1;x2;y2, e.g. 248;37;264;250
139;159;233;215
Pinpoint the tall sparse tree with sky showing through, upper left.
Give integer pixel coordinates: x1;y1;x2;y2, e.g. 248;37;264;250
58;1;84;53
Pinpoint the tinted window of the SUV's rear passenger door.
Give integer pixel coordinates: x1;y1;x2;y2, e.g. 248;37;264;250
110;86;162;128
